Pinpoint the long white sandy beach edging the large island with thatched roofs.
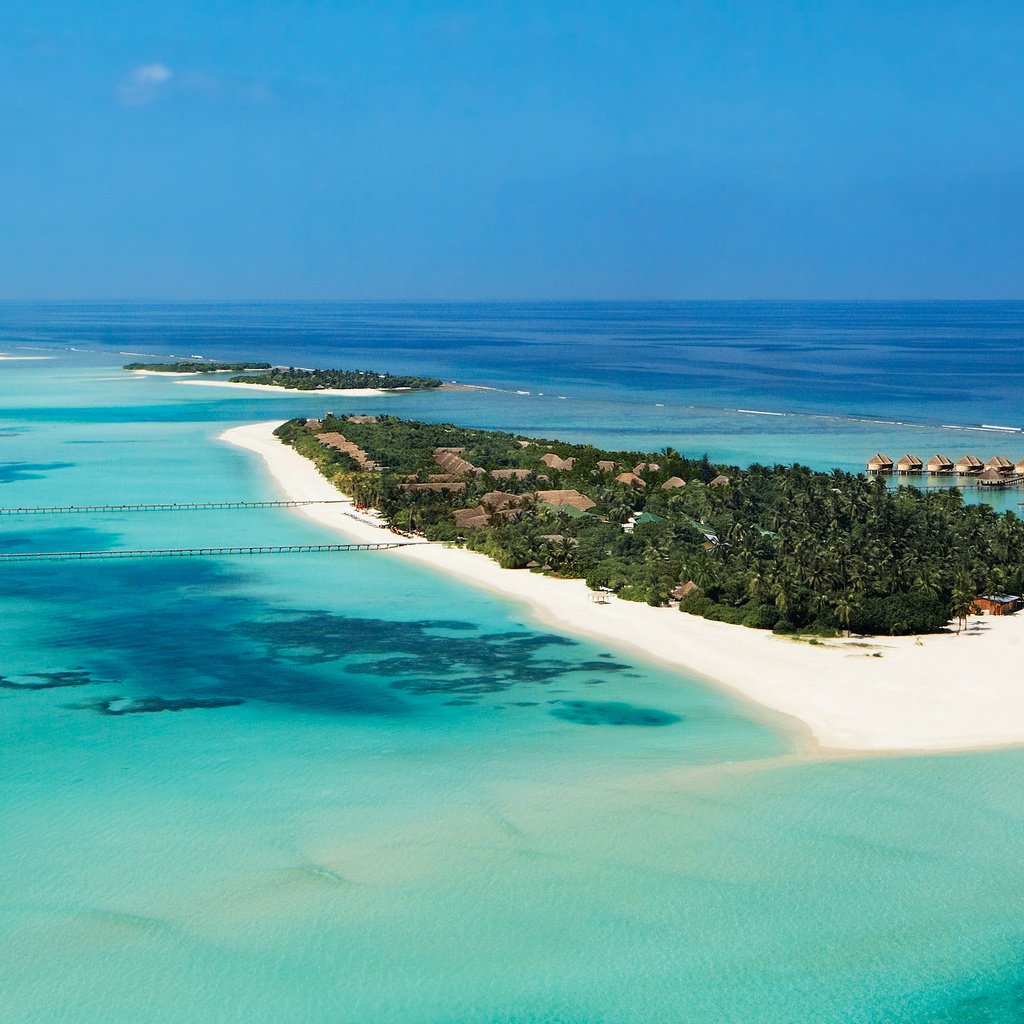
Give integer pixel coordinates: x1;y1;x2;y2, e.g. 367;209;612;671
220;422;1024;752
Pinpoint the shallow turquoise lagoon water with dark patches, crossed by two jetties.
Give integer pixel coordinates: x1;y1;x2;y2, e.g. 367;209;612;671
0;315;1024;1024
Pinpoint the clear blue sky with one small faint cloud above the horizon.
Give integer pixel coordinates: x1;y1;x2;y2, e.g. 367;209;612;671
0;0;1024;300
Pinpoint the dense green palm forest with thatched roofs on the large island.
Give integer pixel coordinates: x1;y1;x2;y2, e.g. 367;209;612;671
275;416;1024;636
